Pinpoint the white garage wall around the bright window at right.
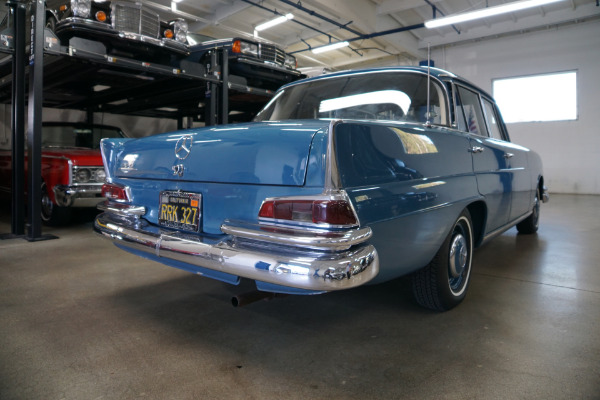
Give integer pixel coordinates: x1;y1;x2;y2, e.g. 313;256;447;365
432;21;600;194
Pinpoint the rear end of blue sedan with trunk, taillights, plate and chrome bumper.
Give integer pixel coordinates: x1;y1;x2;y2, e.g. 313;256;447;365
96;122;378;293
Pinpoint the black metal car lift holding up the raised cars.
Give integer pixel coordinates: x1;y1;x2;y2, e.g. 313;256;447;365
0;0;274;241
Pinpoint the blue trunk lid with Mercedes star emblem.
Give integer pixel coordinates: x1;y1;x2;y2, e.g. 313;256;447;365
115;121;327;186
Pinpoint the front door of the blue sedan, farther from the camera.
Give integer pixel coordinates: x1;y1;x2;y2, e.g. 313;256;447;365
482;97;534;221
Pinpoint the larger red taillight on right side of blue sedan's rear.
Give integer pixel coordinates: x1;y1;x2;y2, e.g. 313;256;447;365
258;198;358;226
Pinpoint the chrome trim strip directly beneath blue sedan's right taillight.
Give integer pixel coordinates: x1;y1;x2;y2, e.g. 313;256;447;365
221;221;373;250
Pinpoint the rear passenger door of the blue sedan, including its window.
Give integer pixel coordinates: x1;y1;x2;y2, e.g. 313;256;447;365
456;85;512;233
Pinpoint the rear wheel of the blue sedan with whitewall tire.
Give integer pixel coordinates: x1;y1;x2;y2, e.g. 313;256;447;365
412;209;473;311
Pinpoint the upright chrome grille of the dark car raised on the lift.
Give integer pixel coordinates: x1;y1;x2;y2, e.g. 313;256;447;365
112;2;160;38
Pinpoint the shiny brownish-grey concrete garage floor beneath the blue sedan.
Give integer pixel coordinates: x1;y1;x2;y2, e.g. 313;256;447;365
0;195;600;400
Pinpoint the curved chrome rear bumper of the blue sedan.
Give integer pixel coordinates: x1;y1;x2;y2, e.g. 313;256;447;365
94;206;379;292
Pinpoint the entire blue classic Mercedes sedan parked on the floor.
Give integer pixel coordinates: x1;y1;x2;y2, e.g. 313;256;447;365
95;68;545;310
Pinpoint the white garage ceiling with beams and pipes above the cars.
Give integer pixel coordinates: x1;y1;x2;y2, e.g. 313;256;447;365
103;0;600;70
